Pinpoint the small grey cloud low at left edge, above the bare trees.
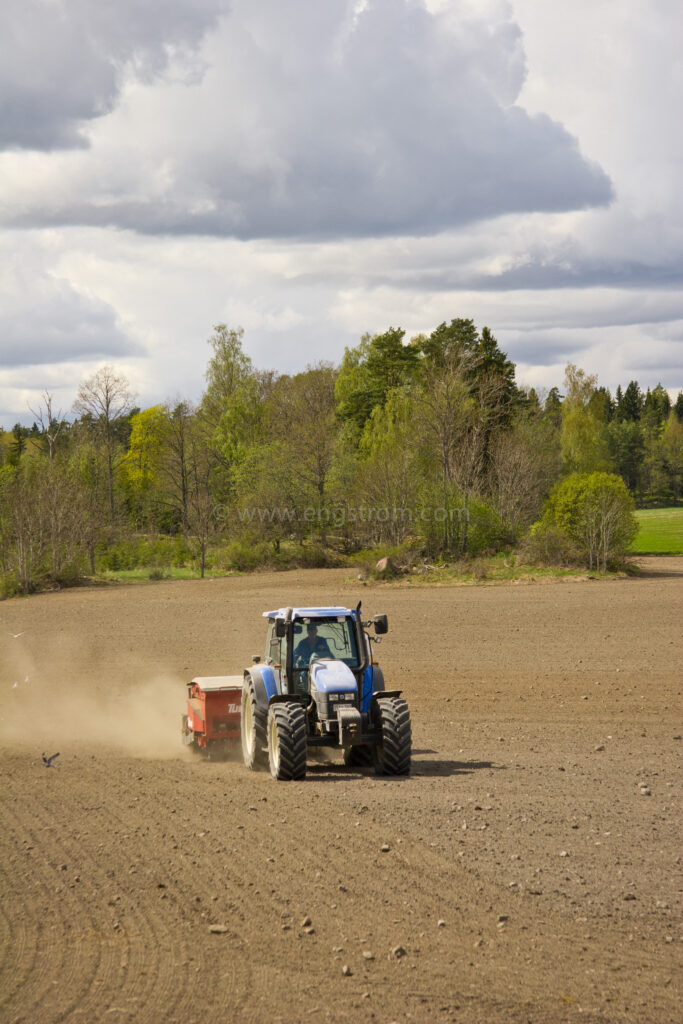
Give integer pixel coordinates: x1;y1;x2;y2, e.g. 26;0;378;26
0;279;144;370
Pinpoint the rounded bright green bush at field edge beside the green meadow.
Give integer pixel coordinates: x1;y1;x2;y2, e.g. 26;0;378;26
531;473;638;571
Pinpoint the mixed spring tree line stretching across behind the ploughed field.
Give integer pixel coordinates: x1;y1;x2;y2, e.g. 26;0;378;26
0;318;683;592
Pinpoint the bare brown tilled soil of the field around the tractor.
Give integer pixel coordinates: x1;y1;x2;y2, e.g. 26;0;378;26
0;558;683;1024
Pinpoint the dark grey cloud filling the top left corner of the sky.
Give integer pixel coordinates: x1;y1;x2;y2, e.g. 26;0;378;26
0;0;223;151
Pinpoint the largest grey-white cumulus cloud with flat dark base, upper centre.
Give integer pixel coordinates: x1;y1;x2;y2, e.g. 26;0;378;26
4;0;612;239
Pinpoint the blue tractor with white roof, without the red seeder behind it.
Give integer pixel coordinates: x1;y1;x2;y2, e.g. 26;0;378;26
241;603;412;779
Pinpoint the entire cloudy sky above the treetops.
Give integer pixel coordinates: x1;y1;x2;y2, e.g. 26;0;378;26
0;0;683;429
